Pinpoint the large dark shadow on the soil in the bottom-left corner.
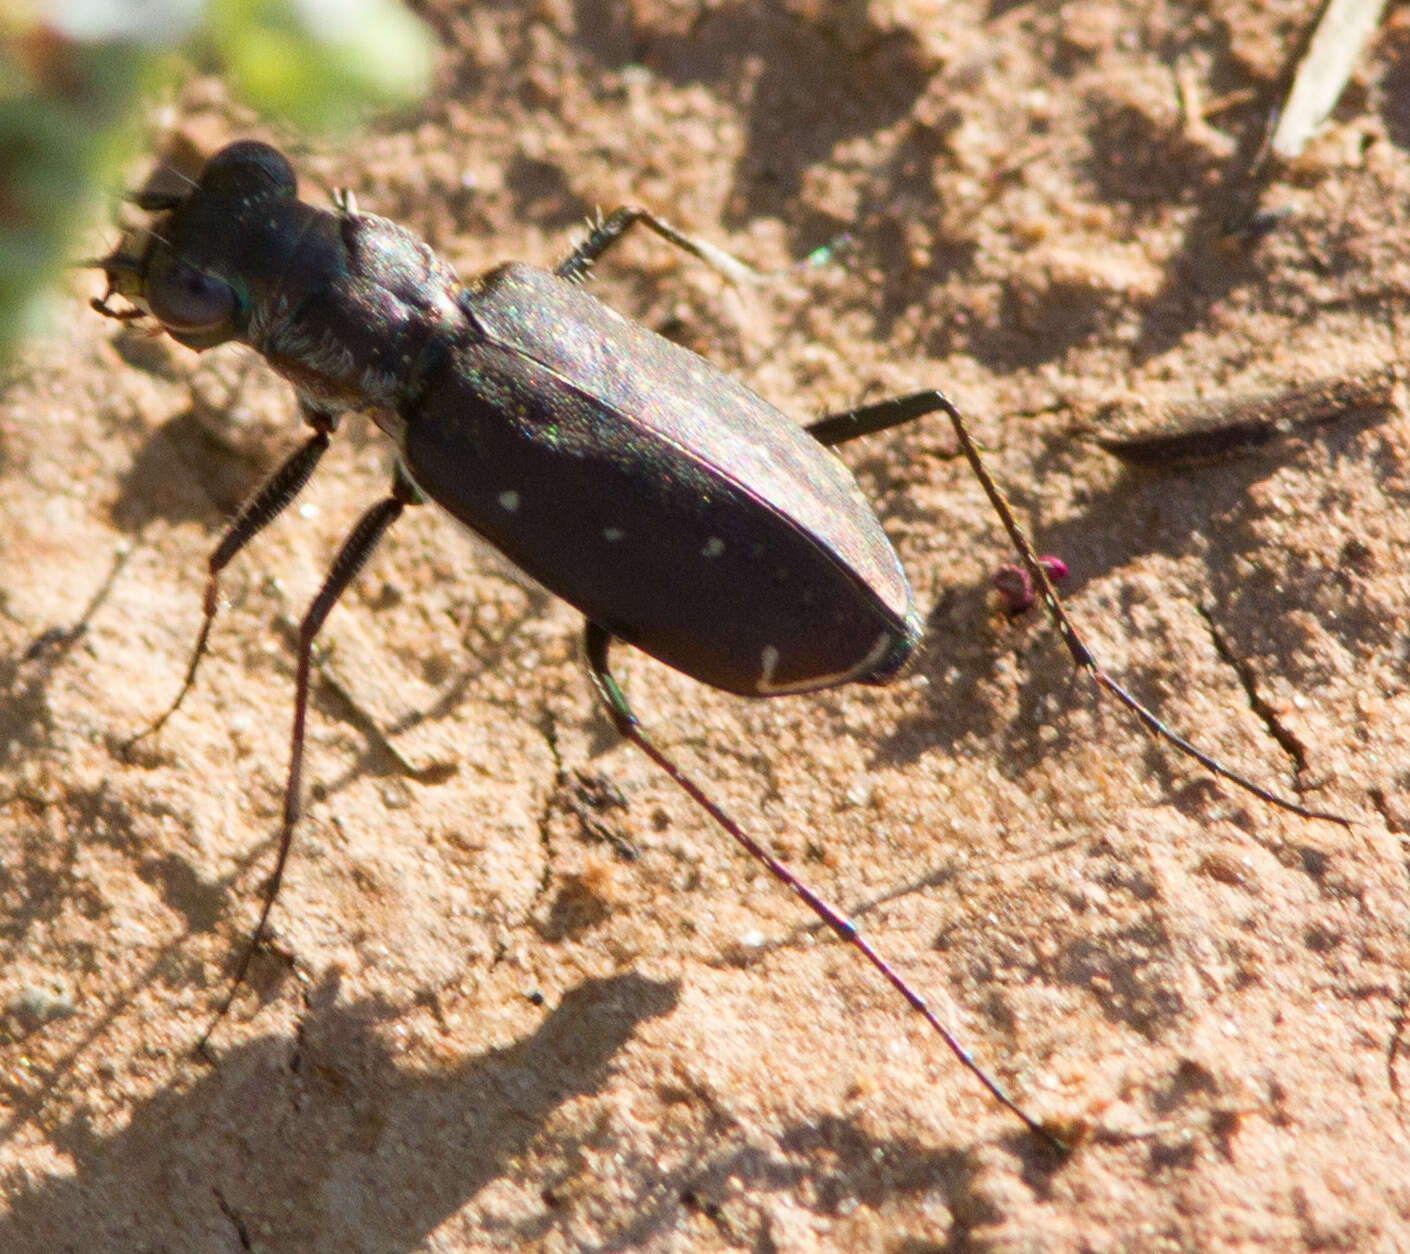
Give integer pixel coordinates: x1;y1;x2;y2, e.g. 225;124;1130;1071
0;975;678;1251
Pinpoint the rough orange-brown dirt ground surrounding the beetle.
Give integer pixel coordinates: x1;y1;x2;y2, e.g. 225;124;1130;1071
0;0;1410;1254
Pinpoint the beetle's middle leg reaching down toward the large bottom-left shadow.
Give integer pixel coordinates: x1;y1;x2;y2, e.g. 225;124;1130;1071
196;457;423;1057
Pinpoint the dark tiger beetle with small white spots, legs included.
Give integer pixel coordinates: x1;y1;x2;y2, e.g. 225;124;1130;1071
89;141;1345;1150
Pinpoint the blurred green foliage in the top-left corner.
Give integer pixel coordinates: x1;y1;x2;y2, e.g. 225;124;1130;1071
0;0;433;361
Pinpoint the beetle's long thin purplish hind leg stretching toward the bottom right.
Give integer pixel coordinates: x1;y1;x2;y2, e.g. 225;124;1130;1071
584;621;1067;1154
